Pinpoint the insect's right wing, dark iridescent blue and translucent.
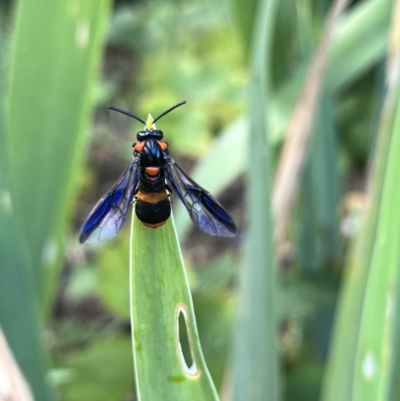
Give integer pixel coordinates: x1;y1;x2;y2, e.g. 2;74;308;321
165;156;236;237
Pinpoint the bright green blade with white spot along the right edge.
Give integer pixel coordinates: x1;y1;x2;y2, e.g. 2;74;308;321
353;64;400;401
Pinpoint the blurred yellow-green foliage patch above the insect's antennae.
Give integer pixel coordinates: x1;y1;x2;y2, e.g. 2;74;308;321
110;0;246;157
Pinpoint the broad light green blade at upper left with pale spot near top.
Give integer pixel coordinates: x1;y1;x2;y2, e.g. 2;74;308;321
8;0;109;306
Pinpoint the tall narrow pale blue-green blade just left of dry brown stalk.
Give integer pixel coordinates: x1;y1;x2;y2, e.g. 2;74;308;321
232;0;280;401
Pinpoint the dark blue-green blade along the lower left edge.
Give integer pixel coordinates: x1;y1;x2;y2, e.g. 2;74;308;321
0;28;51;401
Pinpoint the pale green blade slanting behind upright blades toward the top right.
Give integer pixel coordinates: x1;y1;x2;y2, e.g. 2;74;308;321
177;0;391;238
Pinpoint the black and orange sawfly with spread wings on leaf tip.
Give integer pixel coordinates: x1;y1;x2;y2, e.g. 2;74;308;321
79;101;236;244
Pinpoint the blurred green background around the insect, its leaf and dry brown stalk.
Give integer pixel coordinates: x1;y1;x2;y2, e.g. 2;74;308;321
0;0;400;401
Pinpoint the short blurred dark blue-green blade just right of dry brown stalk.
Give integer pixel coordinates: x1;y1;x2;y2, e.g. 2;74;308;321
297;99;339;269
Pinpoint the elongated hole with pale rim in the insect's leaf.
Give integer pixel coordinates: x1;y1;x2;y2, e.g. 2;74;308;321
176;304;198;376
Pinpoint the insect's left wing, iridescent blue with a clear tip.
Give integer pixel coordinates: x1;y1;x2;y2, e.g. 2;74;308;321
79;157;140;244
